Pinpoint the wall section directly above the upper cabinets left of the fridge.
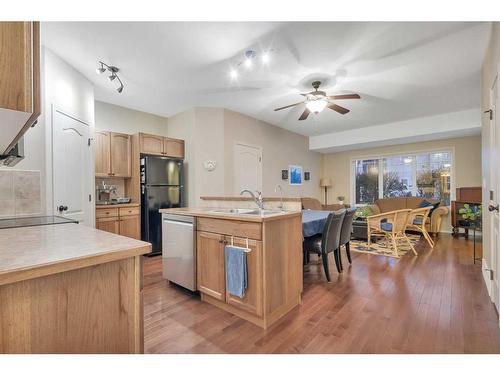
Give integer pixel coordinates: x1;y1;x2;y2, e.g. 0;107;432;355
95;100;167;135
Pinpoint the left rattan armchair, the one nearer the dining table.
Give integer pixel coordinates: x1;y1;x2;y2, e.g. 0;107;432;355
366;209;418;258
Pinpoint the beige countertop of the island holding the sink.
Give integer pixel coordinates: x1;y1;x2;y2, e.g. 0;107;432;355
160;207;302;223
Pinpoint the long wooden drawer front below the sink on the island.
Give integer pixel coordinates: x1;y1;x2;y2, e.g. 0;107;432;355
197;217;262;240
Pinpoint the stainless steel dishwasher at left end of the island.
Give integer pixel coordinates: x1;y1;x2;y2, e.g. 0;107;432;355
162;214;196;291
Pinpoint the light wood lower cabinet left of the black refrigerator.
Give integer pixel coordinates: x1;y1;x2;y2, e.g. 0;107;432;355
95;207;141;240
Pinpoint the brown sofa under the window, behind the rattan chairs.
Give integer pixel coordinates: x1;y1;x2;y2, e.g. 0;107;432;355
369;197;450;234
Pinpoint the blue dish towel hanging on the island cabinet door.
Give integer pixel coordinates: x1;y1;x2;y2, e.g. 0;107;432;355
224;245;247;298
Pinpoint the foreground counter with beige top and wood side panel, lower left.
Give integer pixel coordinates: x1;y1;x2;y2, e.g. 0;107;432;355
0;224;151;353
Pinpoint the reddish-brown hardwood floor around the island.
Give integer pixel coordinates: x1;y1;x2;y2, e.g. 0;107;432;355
144;235;500;353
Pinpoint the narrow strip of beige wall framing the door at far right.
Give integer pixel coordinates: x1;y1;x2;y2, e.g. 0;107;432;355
481;22;500;288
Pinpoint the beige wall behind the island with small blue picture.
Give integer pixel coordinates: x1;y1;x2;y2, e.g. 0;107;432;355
167;107;322;206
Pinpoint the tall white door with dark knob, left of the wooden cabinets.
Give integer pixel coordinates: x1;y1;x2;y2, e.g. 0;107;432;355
52;108;94;226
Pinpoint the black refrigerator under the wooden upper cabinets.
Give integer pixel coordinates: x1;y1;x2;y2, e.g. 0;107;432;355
141;156;184;255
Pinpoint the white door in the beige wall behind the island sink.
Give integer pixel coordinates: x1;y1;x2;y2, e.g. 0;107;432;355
233;143;262;195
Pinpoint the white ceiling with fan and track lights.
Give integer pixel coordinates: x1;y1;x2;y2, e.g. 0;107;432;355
42;22;490;136
